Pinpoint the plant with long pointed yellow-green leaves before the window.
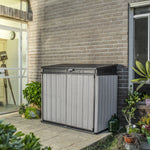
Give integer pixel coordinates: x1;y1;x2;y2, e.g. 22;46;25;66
131;60;150;91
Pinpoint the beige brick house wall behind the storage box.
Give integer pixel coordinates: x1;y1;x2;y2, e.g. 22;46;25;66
28;0;142;123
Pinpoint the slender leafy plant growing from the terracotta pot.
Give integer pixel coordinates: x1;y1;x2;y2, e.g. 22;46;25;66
122;89;141;126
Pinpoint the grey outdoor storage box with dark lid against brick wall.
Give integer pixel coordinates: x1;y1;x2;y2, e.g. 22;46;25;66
42;64;118;133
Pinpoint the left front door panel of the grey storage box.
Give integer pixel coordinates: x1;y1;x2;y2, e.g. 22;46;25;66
42;74;66;124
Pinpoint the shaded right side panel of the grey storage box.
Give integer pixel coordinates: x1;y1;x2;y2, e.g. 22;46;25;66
94;75;118;133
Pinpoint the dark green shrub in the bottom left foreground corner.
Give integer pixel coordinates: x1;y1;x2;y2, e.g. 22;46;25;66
0;121;51;150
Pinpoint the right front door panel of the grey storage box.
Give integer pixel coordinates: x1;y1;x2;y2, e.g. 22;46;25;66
67;74;94;131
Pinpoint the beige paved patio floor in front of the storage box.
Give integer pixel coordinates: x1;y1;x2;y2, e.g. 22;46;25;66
0;113;110;150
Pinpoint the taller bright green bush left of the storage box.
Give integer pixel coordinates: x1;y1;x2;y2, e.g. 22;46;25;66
23;81;41;108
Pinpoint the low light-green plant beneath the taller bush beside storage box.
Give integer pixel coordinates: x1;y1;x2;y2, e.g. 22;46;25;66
25;107;40;119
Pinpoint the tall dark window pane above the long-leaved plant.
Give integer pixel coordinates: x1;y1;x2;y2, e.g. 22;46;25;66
134;18;148;64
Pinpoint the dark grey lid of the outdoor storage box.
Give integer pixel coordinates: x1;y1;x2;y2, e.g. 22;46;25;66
42;64;117;75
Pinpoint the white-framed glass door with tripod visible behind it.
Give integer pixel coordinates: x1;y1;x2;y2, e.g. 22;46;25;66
0;19;27;114
